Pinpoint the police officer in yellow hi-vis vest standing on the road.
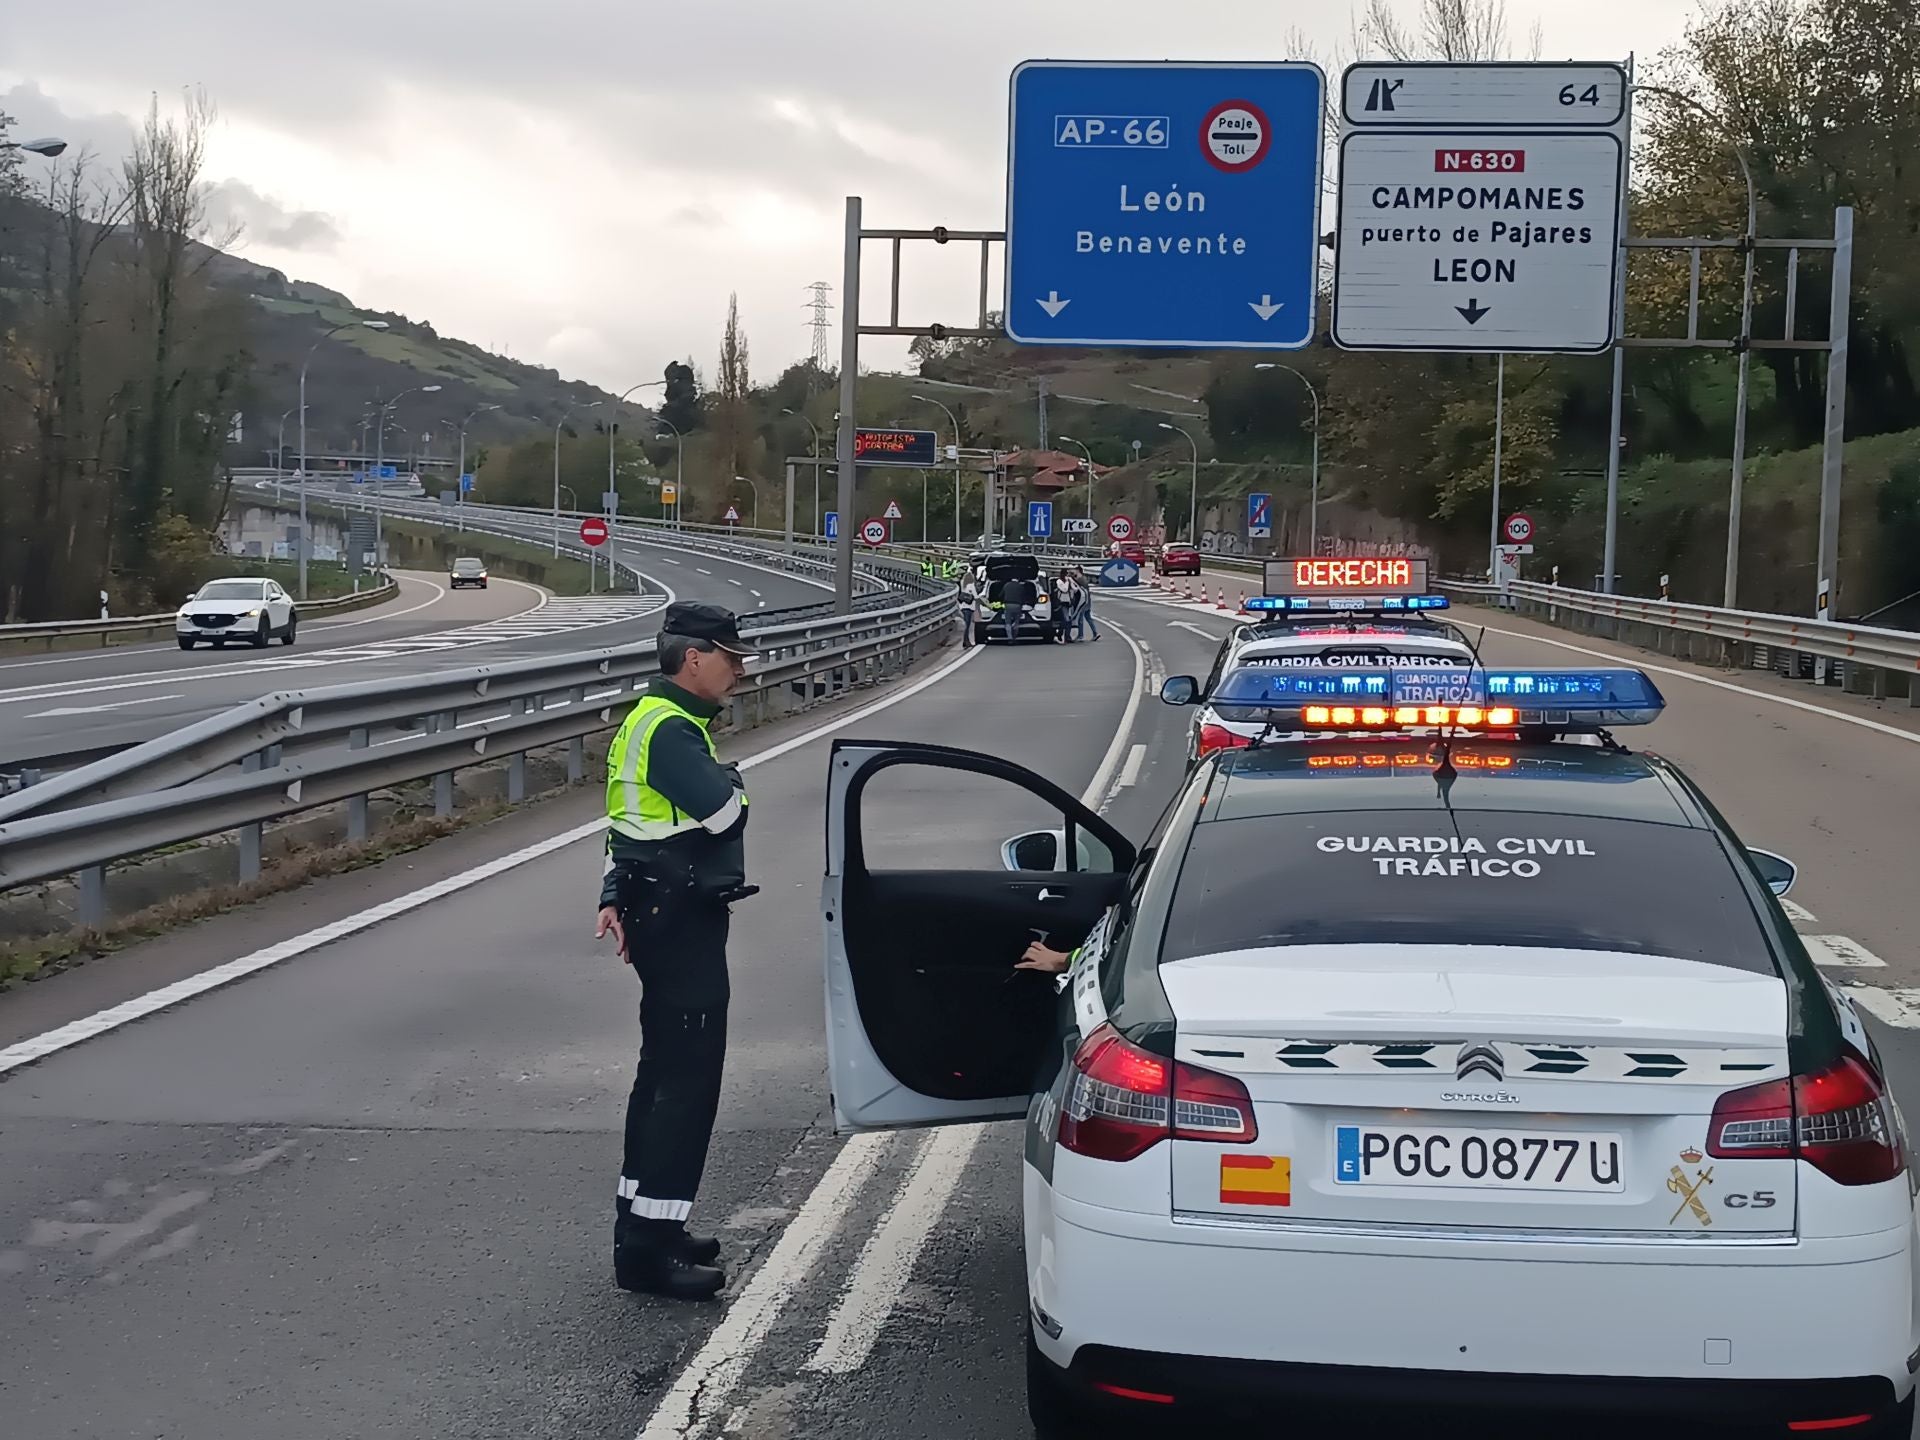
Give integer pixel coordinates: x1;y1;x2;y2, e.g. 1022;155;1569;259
595;601;758;1300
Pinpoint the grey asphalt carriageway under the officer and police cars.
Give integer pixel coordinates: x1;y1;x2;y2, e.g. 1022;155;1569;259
0;579;1920;1440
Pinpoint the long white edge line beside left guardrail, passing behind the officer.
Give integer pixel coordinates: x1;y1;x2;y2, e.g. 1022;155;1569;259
0;651;979;1075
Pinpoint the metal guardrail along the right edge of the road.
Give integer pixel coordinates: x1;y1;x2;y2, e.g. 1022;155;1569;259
1436;580;1920;707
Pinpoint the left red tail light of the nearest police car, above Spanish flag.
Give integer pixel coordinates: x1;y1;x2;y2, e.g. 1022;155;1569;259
1060;1025;1260;1160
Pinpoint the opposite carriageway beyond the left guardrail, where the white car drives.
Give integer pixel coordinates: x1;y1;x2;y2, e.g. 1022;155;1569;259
0;541;829;768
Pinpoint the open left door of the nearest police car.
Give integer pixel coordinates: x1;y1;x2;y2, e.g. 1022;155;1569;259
822;739;1135;1133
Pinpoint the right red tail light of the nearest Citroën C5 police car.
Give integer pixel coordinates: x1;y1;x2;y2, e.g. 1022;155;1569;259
1707;1050;1907;1185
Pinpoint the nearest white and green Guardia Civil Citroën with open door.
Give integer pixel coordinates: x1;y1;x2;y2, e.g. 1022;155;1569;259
824;668;1920;1436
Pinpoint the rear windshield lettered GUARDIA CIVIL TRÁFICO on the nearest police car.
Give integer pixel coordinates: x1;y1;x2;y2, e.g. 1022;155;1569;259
1160;810;1776;975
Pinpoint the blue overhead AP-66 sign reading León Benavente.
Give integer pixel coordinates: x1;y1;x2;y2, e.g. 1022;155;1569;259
1004;60;1327;349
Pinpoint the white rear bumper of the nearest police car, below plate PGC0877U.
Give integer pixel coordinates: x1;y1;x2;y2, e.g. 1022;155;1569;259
1027;1198;1916;1421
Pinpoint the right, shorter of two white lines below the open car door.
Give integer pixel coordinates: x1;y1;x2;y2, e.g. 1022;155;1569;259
806;1125;987;1375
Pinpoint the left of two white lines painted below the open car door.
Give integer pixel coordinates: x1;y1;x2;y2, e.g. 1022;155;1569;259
636;1135;893;1440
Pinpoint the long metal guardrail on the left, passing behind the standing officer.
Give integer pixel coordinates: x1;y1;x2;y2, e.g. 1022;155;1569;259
0;578;954;924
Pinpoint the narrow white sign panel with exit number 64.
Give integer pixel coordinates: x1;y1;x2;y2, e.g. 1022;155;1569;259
1342;61;1626;129
